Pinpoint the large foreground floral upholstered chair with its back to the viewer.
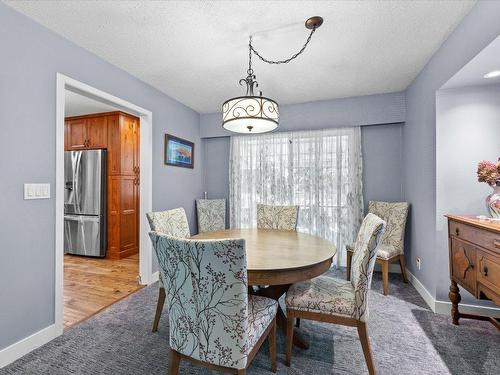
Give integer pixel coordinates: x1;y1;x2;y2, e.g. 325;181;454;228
150;232;278;375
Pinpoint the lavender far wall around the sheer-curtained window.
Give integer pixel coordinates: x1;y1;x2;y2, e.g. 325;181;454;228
200;93;405;222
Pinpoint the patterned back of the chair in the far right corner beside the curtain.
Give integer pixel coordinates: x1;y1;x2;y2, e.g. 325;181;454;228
368;201;410;255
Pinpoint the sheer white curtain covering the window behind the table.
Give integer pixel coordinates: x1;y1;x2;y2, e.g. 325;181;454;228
229;127;363;265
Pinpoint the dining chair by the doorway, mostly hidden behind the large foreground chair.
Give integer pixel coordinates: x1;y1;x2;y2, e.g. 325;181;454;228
146;208;191;332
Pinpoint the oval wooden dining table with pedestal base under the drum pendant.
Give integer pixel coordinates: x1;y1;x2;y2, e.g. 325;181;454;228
192;229;337;349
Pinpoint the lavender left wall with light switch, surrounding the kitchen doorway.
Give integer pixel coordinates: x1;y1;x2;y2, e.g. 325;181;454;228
0;3;203;349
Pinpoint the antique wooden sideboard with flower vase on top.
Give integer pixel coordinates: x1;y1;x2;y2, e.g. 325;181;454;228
446;215;500;329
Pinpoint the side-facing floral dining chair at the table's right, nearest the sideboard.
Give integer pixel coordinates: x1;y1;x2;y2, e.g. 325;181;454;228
285;213;385;374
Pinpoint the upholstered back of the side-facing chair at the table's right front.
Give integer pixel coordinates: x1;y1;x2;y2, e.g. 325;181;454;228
351;213;385;321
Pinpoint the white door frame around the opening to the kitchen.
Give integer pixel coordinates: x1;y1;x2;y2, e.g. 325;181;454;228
54;73;154;335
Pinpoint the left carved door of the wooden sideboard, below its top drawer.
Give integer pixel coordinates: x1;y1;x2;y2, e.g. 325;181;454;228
450;238;477;295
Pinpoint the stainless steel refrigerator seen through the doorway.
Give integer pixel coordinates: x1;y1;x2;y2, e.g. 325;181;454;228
64;150;106;257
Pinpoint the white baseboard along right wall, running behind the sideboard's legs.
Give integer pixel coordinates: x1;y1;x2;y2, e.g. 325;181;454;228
406;269;500;317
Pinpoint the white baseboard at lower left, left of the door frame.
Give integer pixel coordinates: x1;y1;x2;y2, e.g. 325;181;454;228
0;324;58;368
